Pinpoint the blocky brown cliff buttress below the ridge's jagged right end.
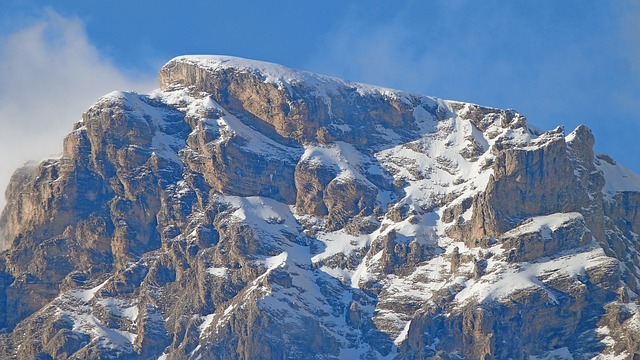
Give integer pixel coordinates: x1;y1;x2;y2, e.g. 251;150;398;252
461;127;604;242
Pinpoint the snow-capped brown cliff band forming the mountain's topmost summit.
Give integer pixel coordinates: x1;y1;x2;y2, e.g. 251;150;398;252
158;57;421;144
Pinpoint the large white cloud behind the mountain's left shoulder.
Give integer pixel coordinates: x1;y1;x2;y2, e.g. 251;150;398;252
0;11;156;214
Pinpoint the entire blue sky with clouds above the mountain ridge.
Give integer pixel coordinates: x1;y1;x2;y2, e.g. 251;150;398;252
0;0;640;197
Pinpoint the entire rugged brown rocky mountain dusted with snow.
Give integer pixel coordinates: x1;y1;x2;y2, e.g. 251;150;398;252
0;56;640;360
